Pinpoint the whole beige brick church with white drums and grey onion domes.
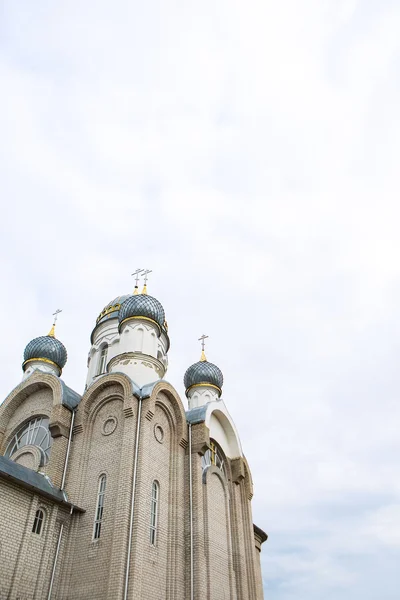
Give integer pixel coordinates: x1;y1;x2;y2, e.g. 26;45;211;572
0;270;267;600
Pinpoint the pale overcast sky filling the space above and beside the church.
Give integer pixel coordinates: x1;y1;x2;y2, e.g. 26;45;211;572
0;0;400;600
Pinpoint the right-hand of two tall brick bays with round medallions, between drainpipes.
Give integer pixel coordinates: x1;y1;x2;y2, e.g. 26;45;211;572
130;395;185;600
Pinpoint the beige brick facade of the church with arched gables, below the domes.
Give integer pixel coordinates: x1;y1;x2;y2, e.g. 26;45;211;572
0;371;265;600
